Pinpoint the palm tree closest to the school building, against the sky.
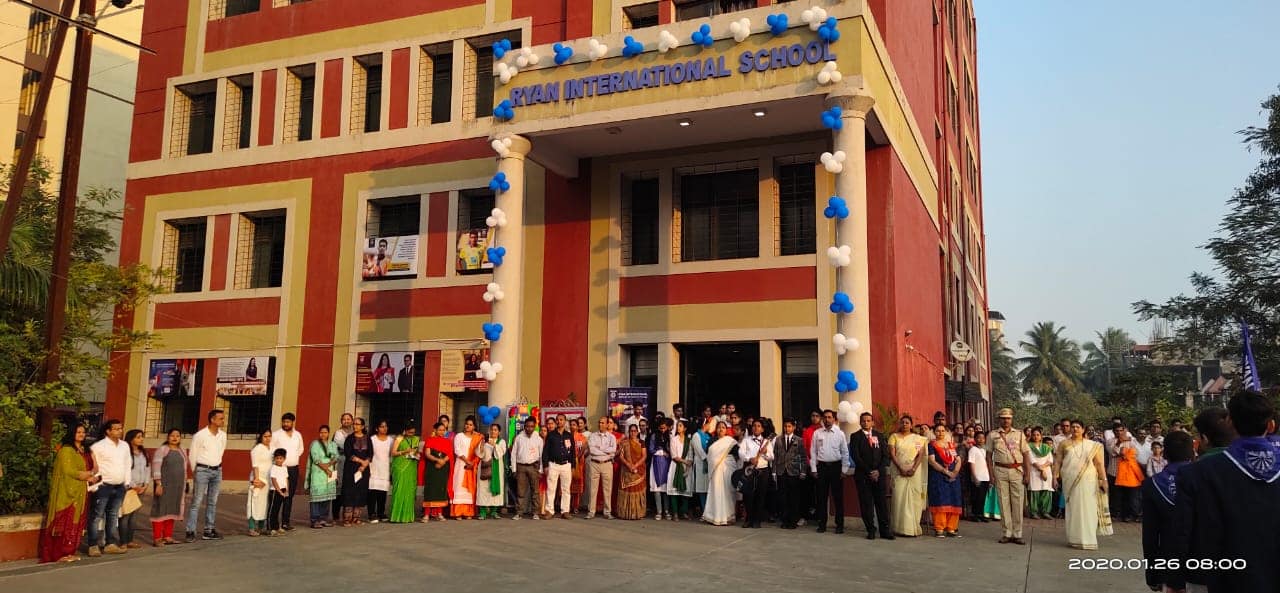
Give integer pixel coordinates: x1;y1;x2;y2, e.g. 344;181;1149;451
1016;321;1080;403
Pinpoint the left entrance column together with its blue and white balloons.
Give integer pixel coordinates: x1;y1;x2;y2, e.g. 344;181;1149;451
481;136;531;410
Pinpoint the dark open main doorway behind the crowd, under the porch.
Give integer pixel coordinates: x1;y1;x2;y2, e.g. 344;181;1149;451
668;342;760;418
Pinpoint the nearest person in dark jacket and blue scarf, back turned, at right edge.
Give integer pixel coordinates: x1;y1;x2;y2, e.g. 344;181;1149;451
1167;391;1280;593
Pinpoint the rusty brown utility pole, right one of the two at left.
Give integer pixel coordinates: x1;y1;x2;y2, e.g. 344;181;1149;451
38;0;97;441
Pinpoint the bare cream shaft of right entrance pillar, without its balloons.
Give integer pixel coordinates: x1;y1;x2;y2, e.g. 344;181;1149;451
822;88;876;427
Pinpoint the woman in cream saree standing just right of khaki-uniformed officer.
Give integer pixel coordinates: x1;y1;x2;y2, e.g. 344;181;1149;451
1049;420;1110;549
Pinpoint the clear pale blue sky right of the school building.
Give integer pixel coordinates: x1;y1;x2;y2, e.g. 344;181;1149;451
975;0;1280;355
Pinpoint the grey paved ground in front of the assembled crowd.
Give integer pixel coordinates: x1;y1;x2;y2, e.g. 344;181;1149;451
0;496;1147;593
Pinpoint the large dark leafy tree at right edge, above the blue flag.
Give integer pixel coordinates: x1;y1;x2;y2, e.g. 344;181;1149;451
1133;88;1280;386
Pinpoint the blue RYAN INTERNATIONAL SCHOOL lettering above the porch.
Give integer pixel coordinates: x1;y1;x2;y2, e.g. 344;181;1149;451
511;41;836;108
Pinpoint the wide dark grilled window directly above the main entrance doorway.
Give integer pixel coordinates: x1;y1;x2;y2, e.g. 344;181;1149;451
676;167;760;261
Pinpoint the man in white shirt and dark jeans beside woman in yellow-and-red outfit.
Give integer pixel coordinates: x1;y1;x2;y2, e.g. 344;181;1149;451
88;420;133;557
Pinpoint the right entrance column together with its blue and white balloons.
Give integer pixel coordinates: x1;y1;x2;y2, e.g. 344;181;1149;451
823;88;874;424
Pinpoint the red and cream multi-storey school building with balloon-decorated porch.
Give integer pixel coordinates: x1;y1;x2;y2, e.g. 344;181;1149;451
106;0;989;479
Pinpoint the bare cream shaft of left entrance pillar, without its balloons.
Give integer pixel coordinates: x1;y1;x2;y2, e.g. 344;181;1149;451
486;136;538;411
